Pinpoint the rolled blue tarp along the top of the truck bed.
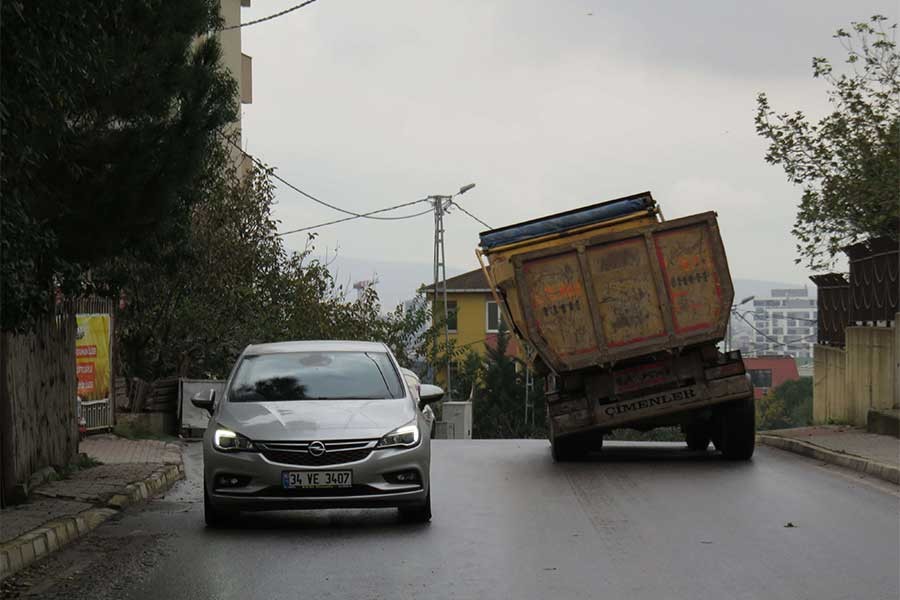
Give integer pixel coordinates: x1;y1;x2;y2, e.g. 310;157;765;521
480;192;655;250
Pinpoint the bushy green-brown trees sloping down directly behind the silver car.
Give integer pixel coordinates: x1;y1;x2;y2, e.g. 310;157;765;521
114;136;429;379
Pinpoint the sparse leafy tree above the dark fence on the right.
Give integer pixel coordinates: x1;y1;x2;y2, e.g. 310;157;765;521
755;15;900;270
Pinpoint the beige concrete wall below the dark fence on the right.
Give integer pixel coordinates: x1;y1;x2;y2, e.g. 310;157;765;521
813;326;900;425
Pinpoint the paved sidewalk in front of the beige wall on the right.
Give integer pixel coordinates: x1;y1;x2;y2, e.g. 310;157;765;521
757;425;900;483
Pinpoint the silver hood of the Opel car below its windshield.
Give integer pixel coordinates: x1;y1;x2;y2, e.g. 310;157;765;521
216;398;416;442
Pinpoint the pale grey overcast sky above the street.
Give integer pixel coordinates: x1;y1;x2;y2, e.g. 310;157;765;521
236;0;898;300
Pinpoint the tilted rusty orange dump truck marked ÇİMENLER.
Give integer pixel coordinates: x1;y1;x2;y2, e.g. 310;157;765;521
476;192;756;461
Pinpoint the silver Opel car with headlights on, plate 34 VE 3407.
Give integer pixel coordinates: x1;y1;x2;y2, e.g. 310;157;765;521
192;342;444;526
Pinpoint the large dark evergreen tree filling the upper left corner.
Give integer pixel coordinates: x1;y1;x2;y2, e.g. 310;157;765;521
0;0;237;329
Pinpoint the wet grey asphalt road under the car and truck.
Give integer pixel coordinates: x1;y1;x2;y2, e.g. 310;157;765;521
4;441;900;600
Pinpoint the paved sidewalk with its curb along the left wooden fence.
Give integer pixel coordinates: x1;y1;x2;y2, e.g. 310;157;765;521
0;435;184;580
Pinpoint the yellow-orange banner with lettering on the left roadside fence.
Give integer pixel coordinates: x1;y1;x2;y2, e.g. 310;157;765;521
75;315;112;400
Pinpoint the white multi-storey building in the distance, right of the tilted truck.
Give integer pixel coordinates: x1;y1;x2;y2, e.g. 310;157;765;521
732;287;818;364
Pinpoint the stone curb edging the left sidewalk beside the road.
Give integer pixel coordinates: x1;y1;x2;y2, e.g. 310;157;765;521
0;464;184;581
